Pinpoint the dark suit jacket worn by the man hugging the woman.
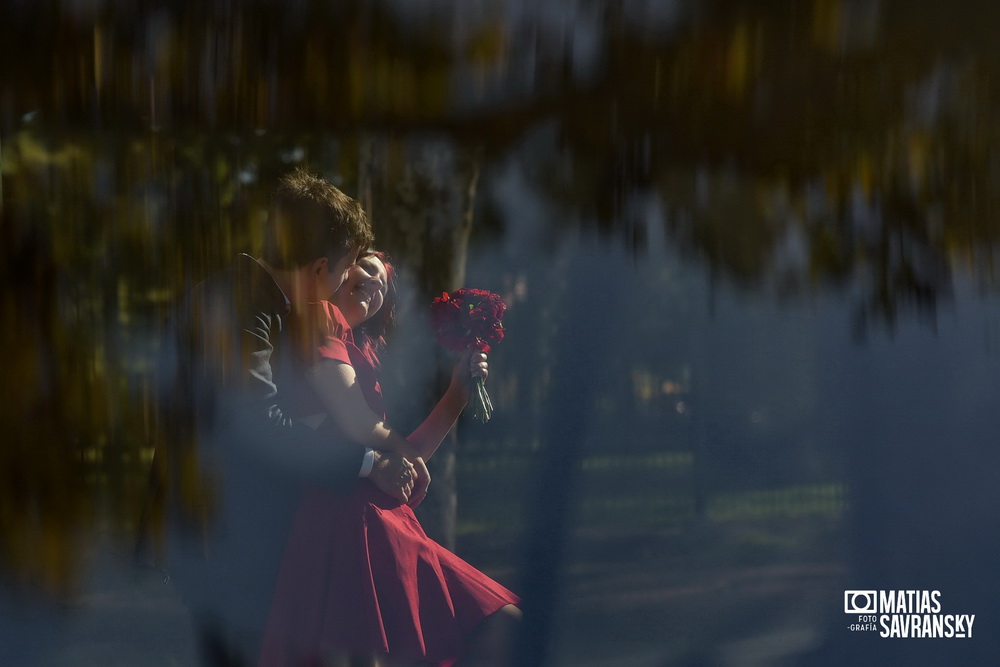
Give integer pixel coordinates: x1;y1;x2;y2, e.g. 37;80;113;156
171;255;363;632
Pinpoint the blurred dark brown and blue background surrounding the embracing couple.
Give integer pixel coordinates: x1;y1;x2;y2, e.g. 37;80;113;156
0;0;1000;665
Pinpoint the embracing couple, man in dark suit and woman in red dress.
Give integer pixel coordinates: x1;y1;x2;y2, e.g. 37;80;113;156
172;171;520;667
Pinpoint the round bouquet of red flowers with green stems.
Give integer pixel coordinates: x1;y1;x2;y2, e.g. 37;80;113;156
431;288;507;424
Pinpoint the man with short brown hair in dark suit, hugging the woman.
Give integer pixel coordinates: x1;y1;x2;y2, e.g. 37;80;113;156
171;171;430;665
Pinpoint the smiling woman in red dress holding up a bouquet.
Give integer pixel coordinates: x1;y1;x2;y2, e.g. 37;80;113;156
260;253;520;667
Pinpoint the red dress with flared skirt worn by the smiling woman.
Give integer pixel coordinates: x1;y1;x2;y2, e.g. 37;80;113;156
260;302;519;667
